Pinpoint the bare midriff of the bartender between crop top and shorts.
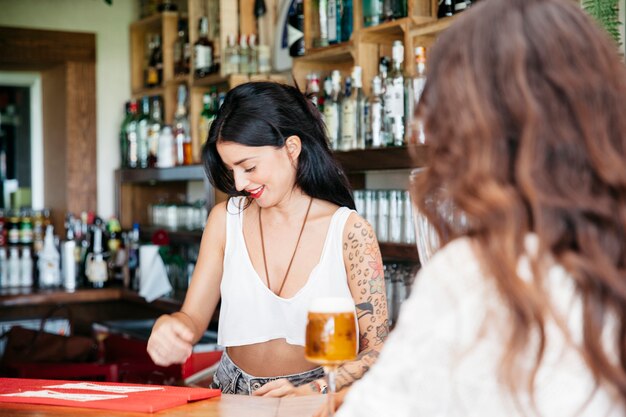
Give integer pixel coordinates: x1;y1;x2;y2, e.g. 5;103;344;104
227;339;317;377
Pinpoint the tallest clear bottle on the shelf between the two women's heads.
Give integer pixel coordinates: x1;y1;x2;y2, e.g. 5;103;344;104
384;41;405;146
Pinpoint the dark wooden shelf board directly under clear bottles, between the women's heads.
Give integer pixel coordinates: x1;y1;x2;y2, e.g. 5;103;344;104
334;145;428;172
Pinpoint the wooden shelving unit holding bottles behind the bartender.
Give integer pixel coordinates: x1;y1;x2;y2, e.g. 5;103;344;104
116;0;455;262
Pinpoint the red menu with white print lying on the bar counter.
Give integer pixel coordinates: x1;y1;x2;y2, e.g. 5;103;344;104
0;378;221;413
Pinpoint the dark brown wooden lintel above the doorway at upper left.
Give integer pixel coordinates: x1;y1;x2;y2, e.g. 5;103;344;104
0;27;96;67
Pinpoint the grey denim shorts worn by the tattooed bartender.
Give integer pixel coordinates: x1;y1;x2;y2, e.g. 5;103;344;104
212;350;324;395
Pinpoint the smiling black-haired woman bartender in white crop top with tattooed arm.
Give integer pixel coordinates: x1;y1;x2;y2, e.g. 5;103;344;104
148;82;388;396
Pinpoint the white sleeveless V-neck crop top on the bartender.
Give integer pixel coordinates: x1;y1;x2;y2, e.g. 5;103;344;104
217;197;352;347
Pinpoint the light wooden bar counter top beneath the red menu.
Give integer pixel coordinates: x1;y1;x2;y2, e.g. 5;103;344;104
0;394;326;417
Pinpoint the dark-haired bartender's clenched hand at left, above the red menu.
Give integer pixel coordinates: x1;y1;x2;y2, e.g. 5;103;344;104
147;315;194;366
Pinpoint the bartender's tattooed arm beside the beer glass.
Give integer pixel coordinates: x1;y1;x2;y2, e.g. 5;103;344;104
337;213;389;390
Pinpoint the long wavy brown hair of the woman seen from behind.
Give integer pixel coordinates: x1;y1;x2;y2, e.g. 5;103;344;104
418;0;626;404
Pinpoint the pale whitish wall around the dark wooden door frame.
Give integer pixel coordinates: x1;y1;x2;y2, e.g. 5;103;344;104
0;0;139;218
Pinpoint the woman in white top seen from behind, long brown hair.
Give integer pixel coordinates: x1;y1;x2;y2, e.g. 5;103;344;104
337;0;626;417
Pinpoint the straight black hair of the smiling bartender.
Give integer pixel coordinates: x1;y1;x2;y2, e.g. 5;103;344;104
202;82;355;209
